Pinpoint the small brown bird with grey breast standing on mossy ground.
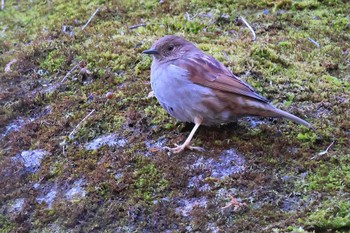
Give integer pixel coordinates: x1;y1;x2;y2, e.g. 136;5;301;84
143;35;312;153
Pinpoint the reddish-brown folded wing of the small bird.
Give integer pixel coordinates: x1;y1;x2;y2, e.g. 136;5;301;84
173;53;268;103
